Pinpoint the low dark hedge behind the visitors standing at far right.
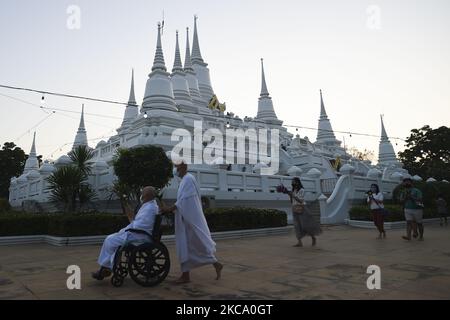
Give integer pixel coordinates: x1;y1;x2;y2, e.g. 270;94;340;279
349;205;438;222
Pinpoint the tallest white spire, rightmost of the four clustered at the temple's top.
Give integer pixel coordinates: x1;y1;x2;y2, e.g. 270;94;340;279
191;16;214;106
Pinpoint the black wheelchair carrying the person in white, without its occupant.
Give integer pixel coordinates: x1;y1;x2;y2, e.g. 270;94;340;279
111;214;170;287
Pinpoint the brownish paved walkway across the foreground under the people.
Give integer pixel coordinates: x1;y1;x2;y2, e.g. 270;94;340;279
0;226;450;299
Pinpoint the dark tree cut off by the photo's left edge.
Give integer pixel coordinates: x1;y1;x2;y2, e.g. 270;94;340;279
0;142;27;199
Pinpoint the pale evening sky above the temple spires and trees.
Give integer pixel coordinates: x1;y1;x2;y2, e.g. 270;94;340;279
0;0;450;159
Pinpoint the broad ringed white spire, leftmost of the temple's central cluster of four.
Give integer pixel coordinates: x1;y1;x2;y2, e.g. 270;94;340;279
141;24;178;112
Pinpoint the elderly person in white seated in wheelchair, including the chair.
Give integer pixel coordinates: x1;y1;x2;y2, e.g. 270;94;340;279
92;186;170;287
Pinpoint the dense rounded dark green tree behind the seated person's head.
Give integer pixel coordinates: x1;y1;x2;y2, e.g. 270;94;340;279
113;146;172;200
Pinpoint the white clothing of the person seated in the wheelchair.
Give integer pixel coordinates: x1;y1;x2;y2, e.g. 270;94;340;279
98;200;159;269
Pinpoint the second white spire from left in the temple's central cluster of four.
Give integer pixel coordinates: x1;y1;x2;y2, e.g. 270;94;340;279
170;31;198;112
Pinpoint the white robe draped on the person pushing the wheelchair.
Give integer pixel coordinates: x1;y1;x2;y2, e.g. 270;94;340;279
175;173;217;272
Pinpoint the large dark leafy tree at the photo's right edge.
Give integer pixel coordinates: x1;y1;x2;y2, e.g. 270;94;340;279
398;126;450;180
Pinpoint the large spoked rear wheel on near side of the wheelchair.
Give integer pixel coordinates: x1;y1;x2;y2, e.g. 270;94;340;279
128;243;170;287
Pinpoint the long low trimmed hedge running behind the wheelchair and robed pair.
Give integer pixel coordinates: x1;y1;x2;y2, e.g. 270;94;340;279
0;208;287;237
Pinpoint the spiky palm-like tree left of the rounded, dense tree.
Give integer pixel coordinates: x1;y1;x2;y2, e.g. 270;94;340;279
47;146;96;212
